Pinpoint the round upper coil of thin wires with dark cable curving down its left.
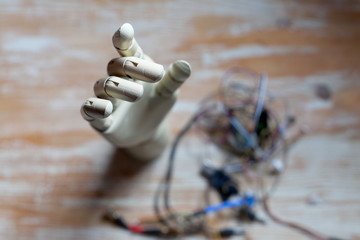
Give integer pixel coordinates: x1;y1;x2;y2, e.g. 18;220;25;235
154;68;284;234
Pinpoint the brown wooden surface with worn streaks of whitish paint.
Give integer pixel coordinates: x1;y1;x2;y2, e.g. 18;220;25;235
0;0;360;240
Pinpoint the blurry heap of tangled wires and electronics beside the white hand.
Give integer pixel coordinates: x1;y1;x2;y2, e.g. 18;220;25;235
106;68;348;240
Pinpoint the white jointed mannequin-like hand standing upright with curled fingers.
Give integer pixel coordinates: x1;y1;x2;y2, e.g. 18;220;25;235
81;23;191;160
